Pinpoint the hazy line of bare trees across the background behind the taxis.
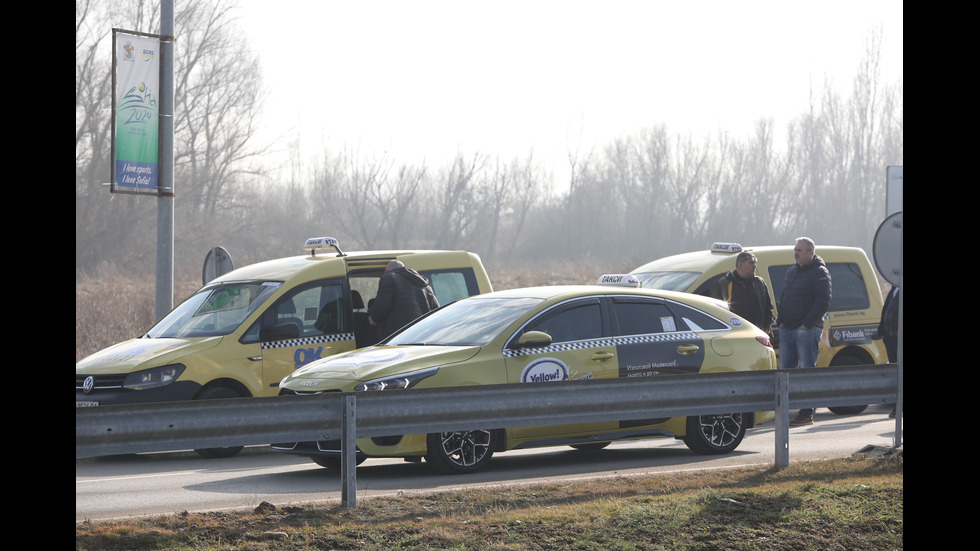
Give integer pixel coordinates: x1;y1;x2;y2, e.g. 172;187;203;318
75;0;904;278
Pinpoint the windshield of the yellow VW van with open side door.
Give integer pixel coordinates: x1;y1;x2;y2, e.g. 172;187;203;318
146;281;282;338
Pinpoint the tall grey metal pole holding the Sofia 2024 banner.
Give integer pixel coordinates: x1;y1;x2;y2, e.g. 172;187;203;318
156;0;176;319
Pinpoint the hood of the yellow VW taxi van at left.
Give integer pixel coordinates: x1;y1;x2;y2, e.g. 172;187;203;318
75;337;221;375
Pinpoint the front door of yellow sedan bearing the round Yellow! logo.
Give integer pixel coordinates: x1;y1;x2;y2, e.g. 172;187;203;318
505;297;619;439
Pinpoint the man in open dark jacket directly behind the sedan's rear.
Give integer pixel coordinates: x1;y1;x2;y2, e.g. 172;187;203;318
711;251;773;334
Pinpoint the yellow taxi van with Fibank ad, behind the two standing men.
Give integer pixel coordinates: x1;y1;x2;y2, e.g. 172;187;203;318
630;242;888;413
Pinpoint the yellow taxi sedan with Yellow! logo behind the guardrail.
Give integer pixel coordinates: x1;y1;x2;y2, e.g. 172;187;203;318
272;275;776;473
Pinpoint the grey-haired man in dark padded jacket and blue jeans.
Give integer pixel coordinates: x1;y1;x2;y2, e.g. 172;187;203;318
777;237;832;427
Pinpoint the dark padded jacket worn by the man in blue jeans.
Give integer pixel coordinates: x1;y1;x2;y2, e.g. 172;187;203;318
778;255;832;329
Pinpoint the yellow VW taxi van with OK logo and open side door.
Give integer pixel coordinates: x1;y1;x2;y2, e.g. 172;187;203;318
75;237;493;456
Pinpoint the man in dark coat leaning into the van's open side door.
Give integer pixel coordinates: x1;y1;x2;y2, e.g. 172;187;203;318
368;260;439;338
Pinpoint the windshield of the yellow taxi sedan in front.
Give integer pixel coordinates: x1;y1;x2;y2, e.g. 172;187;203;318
384;297;542;346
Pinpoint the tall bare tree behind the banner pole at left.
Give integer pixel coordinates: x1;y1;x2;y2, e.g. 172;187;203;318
75;0;272;276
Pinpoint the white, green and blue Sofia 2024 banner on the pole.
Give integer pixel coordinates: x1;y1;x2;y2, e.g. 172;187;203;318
110;29;160;195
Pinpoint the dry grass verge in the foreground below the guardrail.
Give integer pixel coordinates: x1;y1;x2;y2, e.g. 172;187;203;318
75;456;904;551
